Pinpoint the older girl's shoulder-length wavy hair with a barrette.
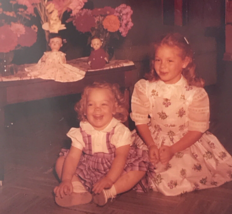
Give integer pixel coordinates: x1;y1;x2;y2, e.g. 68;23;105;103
145;33;204;87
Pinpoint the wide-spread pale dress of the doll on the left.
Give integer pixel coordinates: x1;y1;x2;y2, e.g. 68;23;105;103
25;51;85;82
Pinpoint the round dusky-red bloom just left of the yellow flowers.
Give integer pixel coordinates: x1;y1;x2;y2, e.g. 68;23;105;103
18;26;37;47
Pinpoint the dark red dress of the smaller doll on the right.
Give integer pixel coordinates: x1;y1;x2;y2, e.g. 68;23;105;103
88;48;108;69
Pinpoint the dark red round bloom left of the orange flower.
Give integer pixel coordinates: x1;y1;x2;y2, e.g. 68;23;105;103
73;10;95;33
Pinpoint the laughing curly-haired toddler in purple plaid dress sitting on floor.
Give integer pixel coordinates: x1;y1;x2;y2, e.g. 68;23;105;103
54;83;149;207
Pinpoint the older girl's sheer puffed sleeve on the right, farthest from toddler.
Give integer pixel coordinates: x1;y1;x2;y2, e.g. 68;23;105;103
188;88;209;133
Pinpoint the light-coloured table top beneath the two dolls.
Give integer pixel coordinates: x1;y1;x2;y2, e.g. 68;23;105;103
0;57;134;84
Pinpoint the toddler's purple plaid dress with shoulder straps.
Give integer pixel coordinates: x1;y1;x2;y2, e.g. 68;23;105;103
60;120;151;192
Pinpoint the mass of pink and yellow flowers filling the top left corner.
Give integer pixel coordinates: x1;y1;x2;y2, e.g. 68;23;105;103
0;0;87;53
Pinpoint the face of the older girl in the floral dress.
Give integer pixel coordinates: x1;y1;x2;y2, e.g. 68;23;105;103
154;45;189;84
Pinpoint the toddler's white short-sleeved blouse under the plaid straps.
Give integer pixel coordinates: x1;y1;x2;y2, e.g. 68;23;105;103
67;118;132;153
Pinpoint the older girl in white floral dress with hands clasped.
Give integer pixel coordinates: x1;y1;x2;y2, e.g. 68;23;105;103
131;33;232;196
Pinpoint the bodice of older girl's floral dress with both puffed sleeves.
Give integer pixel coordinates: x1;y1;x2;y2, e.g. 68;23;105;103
130;76;209;132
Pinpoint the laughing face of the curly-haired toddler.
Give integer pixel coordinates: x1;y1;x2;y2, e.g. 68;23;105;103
86;88;115;130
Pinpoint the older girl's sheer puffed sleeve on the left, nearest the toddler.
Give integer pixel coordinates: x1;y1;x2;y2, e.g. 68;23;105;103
130;79;150;125
